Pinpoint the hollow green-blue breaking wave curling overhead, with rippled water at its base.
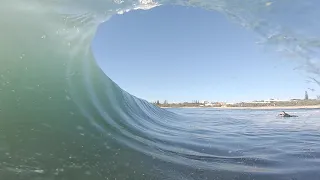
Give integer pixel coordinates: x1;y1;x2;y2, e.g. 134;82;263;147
0;0;320;180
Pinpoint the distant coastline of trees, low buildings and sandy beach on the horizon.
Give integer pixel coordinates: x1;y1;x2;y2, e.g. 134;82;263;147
152;91;320;109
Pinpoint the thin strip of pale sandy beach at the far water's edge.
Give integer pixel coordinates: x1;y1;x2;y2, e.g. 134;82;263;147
160;105;320;110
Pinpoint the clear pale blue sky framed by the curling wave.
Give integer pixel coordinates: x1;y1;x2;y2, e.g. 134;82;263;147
93;6;314;102
